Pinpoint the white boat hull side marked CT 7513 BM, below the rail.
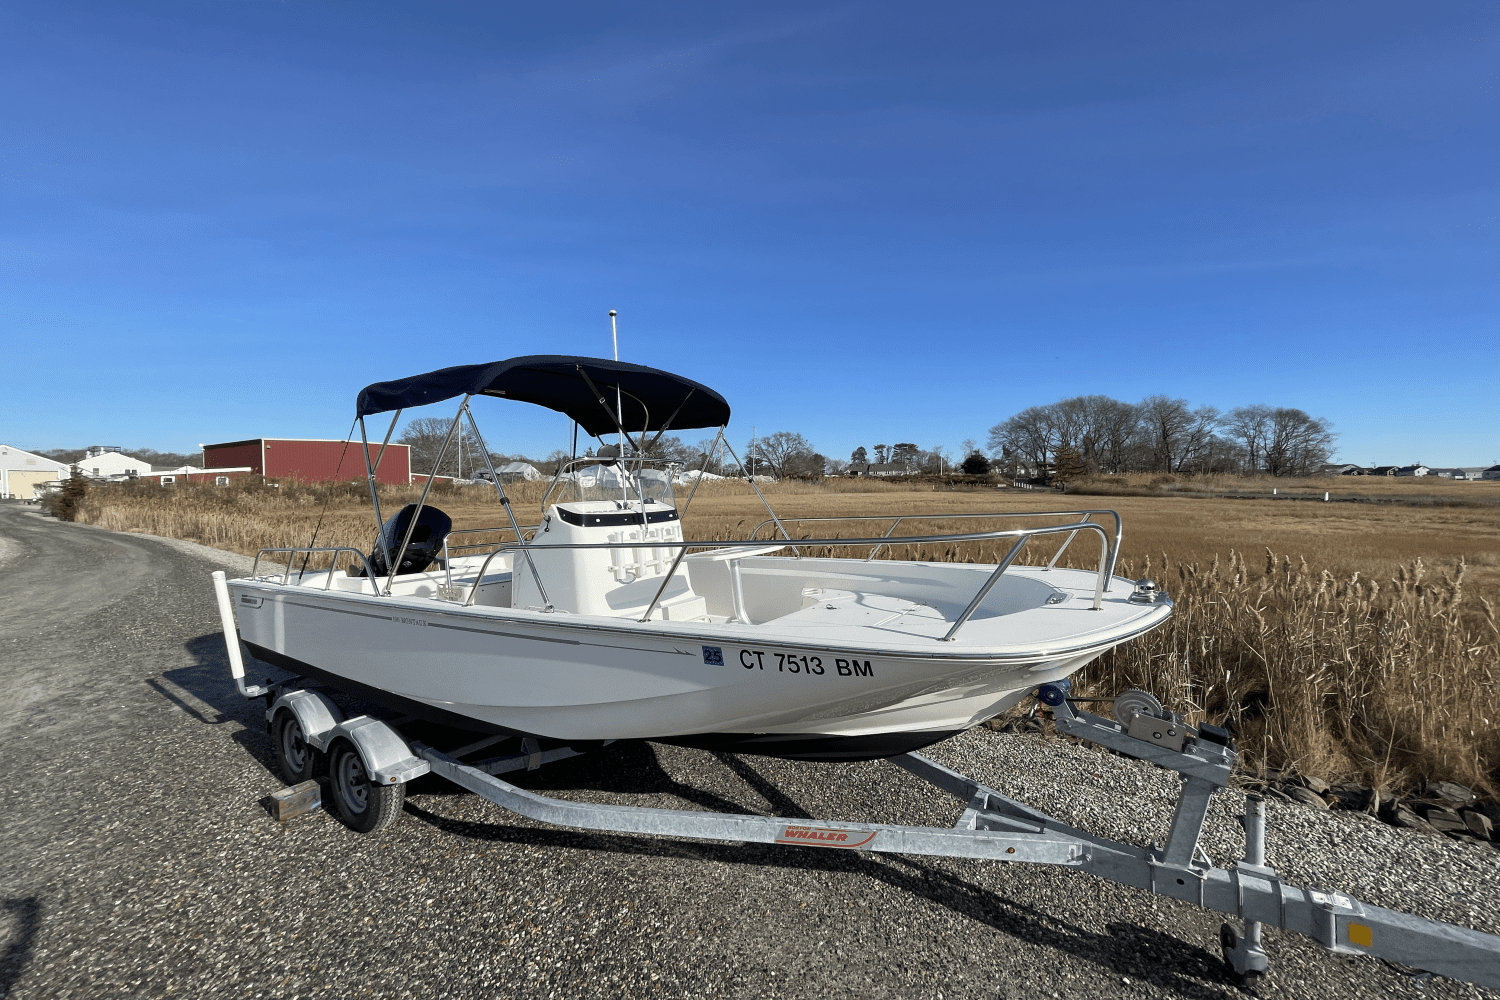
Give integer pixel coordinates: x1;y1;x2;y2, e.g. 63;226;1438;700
231;580;1158;760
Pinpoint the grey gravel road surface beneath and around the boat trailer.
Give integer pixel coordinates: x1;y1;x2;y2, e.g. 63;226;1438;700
0;504;1500;999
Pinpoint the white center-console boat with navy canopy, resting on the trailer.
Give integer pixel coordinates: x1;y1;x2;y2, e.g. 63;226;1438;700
230;355;1172;760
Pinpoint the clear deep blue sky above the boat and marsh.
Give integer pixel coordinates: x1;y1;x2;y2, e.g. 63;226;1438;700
0;0;1500;465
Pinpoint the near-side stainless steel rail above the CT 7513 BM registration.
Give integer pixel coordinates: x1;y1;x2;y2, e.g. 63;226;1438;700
464;521;1112;642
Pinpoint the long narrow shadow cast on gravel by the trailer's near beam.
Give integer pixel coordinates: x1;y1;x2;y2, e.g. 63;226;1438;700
407;791;1242;1000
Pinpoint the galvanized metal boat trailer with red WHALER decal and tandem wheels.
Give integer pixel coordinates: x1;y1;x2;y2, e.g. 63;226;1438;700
215;573;1500;988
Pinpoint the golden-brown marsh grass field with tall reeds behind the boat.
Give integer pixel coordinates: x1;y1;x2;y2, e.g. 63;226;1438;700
78;480;1500;798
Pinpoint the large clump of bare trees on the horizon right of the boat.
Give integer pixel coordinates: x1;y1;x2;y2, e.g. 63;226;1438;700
987;396;1335;475
